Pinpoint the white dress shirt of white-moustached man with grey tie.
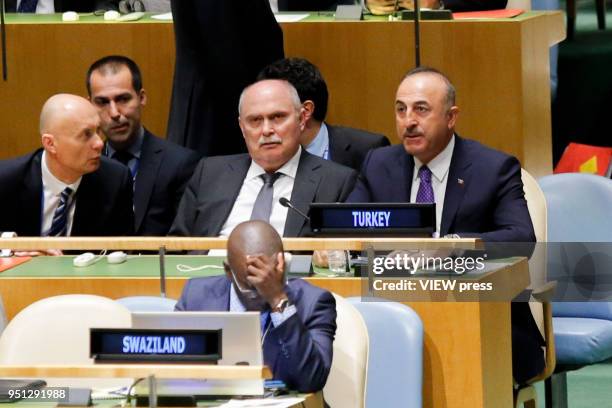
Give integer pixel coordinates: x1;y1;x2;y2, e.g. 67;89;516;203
219;147;302;237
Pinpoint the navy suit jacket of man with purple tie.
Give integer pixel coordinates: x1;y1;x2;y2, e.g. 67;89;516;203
347;136;535;242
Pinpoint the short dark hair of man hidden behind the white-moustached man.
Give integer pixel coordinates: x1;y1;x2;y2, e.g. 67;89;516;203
257;58;329;122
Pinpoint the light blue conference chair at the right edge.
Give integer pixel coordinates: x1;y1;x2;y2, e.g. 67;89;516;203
539;173;612;407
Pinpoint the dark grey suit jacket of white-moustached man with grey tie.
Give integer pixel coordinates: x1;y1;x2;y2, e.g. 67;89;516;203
170;150;357;237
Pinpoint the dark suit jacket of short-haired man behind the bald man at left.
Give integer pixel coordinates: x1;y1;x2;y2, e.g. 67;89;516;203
104;129;200;236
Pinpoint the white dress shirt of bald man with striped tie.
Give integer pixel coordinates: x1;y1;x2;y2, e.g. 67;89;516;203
40;151;82;236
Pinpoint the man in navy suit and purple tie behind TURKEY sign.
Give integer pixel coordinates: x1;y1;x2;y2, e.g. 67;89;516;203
347;67;544;383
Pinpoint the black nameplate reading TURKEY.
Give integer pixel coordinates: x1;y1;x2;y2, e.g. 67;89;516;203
310;203;436;237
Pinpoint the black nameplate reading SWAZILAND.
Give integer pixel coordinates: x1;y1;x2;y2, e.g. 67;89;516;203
90;328;222;363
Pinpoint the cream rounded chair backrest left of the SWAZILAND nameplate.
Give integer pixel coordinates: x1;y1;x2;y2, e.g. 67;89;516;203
0;295;132;365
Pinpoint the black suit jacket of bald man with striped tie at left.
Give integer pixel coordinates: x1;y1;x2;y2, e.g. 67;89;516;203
0;149;134;236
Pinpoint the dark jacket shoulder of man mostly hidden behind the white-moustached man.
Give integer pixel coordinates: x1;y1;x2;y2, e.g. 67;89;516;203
326;123;389;171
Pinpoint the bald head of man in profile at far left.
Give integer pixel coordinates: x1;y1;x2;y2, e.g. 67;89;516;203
40;94;104;184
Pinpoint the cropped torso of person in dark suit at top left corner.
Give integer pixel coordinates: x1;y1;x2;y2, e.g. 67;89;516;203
5;0;119;14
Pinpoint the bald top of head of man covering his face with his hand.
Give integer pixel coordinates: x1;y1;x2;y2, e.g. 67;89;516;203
227;221;283;268
